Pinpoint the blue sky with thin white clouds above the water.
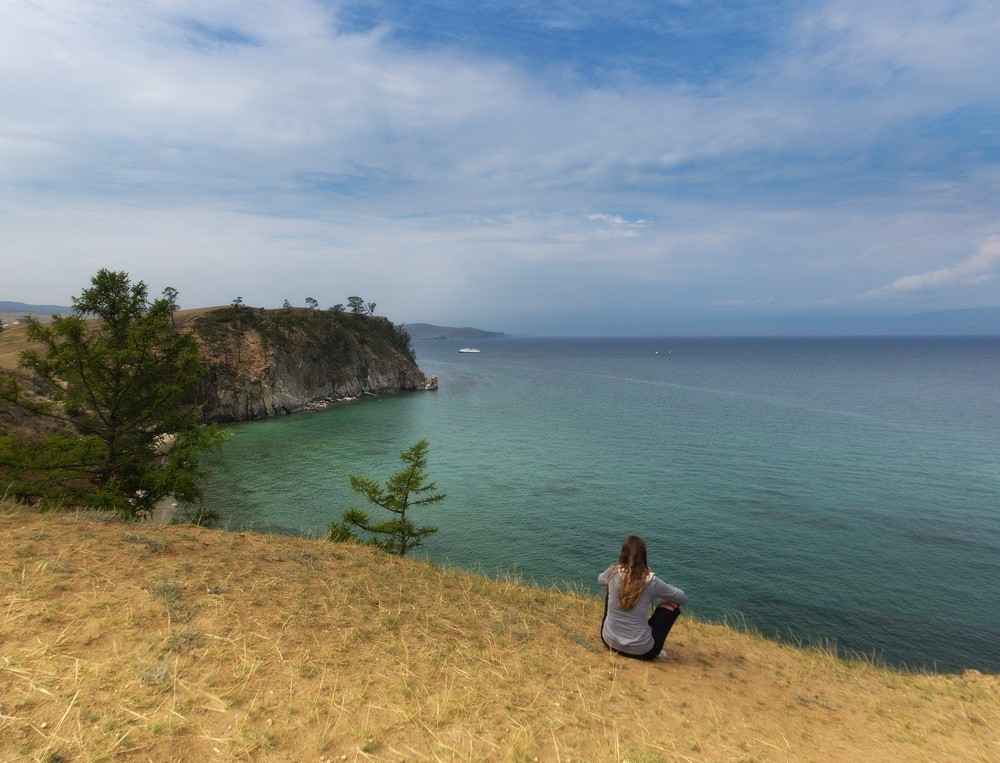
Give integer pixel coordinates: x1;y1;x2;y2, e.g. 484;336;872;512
0;0;1000;335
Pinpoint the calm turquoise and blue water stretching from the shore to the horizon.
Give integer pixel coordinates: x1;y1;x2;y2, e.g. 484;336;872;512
208;338;1000;672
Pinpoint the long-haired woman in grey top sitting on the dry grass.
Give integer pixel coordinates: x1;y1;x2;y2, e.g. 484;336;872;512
597;535;687;660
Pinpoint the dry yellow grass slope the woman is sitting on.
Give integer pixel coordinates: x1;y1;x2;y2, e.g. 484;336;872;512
0;505;1000;763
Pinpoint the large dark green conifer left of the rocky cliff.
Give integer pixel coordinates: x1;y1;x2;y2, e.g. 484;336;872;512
20;269;219;517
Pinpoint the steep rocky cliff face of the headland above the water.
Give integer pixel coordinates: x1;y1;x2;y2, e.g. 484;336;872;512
194;306;433;422
